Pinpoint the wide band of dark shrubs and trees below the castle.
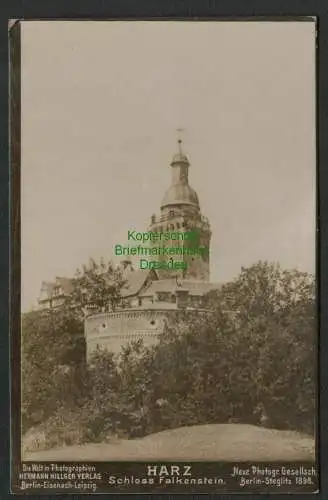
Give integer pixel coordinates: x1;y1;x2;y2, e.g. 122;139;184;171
23;263;317;446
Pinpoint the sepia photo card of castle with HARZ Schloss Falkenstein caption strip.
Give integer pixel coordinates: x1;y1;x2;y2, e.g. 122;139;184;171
11;18;318;494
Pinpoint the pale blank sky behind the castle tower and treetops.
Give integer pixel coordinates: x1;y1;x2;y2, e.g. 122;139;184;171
22;21;316;310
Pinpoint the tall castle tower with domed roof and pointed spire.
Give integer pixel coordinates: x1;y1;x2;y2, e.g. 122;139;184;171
148;139;211;281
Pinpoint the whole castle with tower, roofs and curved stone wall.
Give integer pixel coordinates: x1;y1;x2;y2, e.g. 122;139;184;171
39;140;220;357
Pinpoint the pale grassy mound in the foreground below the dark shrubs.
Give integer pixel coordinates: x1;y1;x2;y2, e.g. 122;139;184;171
24;424;314;461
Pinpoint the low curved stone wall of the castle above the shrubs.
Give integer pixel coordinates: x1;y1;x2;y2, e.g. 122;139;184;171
84;309;178;359
